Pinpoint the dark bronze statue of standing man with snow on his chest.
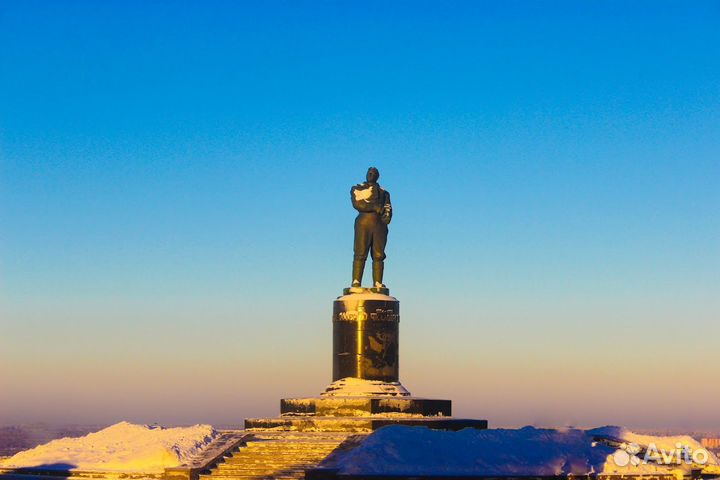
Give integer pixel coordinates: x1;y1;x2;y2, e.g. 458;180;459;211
350;167;392;288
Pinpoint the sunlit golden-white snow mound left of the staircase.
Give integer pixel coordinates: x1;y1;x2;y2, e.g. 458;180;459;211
0;422;218;473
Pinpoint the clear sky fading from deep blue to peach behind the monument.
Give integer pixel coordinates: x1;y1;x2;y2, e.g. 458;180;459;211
0;0;720;430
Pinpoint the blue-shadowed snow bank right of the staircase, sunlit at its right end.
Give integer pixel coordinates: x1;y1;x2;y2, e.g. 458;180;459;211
321;426;717;476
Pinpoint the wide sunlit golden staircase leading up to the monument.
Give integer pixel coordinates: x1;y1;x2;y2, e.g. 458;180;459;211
200;431;364;480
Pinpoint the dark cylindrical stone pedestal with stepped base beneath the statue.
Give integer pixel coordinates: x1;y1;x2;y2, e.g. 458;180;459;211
245;288;487;432
